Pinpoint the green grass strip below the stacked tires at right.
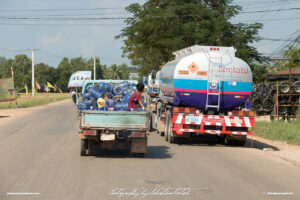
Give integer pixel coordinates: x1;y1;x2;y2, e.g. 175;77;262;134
255;120;300;145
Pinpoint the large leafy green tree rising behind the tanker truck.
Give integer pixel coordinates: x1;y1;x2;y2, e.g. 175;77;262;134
116;0;264;75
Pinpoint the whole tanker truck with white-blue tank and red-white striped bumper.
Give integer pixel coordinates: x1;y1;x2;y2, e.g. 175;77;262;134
153;45;255;146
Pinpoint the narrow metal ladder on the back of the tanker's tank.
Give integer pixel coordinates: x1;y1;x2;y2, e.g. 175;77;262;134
205;56;224;111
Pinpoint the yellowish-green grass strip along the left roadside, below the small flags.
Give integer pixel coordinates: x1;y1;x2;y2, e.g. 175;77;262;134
0;93;71;109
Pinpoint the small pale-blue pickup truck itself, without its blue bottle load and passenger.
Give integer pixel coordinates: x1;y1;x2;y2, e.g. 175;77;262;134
78;80;150;157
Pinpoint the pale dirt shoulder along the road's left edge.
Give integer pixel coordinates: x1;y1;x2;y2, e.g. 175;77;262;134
0;99;72;125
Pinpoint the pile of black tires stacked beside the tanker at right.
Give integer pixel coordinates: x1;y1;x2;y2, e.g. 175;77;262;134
251;81;300;115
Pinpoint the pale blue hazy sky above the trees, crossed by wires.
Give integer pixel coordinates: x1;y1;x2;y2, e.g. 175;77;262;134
0;0;300;67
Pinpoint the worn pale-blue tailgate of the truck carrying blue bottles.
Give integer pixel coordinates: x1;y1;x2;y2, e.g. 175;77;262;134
80;110;149;130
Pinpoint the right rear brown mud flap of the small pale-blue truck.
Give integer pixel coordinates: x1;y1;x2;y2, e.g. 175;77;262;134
130;132;147;154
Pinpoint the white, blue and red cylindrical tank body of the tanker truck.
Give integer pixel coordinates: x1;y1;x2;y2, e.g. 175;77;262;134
160;45;252;110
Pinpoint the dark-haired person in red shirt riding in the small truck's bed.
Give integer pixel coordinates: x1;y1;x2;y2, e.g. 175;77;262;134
128;83;145;111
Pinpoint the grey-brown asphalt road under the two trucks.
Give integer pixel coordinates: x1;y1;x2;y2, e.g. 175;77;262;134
0;101;300;200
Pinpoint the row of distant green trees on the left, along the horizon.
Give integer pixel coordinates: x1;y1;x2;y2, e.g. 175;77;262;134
0;54;130;92
